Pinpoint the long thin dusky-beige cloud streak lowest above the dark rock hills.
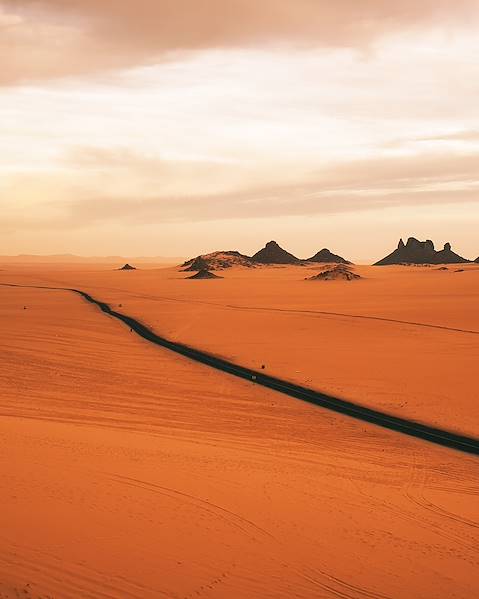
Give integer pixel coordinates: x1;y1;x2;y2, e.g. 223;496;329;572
62;187;479;229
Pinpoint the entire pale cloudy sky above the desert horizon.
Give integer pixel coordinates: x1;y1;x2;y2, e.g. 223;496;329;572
0;0;479;261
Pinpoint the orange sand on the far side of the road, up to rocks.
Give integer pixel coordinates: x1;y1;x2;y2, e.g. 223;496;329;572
0;265;479;436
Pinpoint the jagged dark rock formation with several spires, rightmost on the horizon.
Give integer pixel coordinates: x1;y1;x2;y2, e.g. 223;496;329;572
375;237;469;266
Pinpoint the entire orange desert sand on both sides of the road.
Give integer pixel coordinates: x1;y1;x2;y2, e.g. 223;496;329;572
0;264;479;599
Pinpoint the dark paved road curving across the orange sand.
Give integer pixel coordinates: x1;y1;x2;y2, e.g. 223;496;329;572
0;283;479;455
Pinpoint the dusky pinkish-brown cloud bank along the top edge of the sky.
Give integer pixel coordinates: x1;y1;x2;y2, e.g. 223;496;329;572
0;0;479;84
